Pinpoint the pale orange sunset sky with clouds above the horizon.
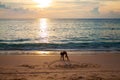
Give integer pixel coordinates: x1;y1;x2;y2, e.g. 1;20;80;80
0;0;120;19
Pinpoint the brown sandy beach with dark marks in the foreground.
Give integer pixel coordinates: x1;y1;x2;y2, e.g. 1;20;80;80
0;52;120;80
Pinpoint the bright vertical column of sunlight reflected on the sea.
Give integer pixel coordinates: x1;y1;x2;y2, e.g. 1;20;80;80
39;18;49;43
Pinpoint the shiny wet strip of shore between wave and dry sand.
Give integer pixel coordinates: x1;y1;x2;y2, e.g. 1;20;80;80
0;50;120;56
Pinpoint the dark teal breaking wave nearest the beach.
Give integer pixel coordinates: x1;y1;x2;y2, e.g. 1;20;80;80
0;42;120;51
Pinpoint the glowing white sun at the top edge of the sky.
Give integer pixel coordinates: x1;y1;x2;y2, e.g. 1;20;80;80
33;0;52;8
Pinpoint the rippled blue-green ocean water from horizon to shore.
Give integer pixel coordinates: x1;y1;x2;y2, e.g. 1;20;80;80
0;18;120;51
